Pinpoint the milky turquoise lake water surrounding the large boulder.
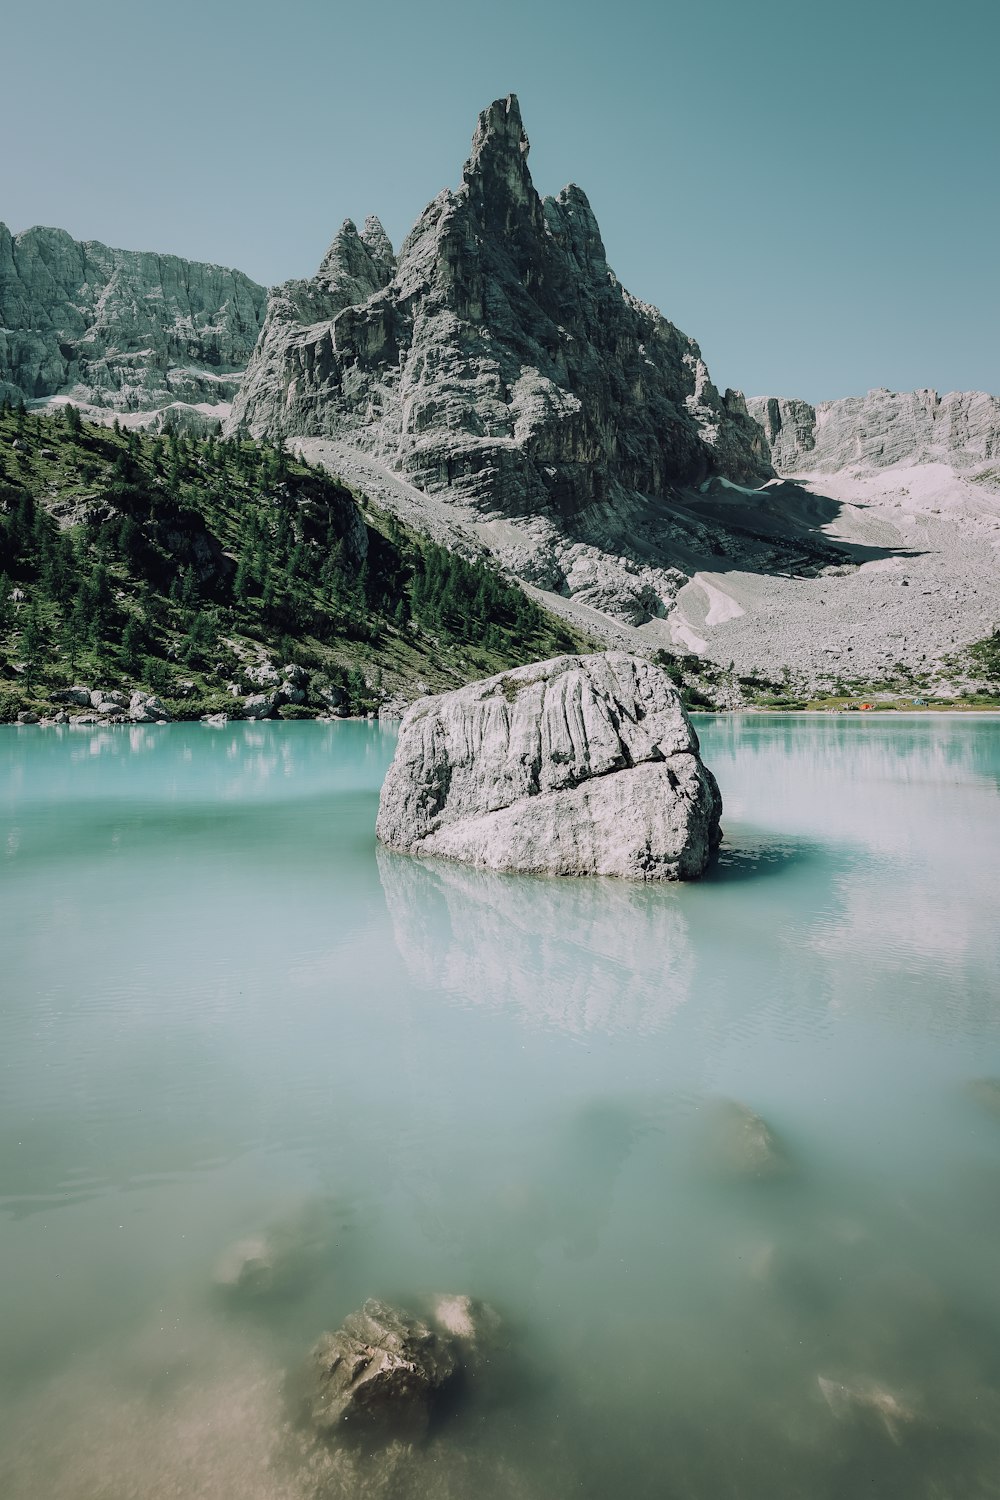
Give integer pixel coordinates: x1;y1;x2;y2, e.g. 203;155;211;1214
0;716;1000;1500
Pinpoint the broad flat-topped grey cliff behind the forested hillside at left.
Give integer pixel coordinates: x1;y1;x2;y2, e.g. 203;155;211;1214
0;224;267;413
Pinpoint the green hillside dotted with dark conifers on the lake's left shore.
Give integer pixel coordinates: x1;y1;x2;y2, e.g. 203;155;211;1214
0;405;586;719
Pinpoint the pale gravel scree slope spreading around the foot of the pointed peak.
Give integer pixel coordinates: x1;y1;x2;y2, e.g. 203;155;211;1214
295;438;1000;686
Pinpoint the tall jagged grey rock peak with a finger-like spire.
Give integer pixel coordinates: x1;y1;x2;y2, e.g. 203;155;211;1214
229;95;772;516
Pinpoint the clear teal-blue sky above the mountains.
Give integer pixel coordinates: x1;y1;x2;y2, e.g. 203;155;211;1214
0;0;1000;401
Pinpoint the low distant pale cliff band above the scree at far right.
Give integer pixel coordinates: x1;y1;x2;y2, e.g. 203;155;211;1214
747;390;1000;474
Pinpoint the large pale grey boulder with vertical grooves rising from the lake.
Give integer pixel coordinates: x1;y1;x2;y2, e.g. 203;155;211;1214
376;651;723;881
